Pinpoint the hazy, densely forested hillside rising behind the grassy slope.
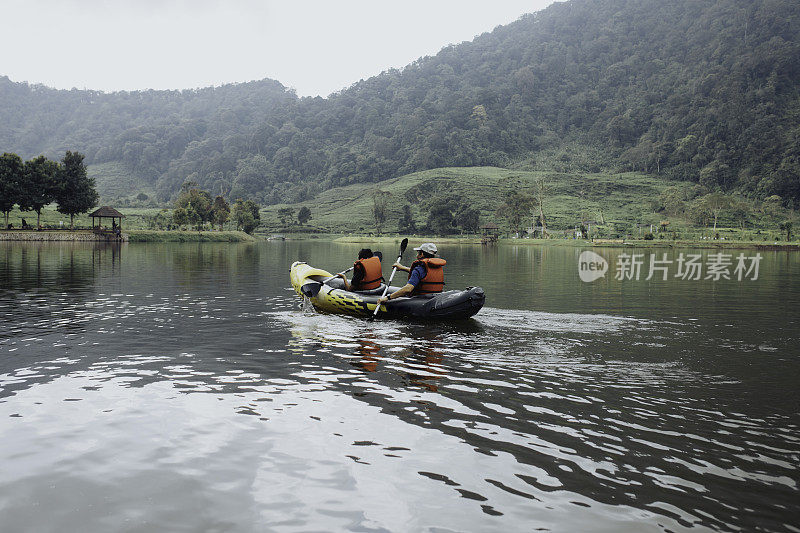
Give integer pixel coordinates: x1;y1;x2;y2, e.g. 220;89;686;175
0;0;800;204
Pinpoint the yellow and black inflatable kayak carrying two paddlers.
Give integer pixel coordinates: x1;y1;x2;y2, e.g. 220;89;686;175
289;261;486;320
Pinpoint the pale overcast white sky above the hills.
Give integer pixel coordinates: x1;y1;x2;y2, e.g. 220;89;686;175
0;0;553;96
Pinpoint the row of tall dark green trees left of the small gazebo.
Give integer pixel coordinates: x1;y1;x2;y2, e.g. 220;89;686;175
0;151;98;229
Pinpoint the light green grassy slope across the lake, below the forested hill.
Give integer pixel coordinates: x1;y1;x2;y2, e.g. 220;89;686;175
261;167;796;241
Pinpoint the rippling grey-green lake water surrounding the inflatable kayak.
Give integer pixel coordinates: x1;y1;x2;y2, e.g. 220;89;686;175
0;242;800;532
